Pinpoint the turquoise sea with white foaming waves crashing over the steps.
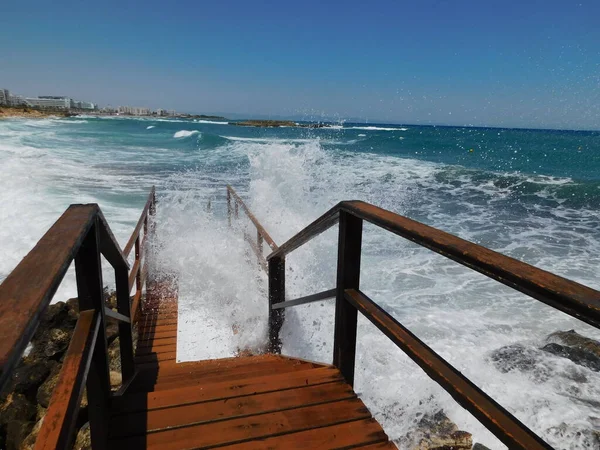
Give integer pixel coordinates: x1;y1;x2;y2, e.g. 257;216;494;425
0;116;600;449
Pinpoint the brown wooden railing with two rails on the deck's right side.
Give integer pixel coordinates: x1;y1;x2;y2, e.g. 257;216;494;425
267;201;600;450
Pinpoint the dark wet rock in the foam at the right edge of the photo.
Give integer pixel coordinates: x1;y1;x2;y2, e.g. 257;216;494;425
542;330;600;372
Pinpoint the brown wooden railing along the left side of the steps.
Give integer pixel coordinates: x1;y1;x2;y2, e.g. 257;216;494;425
0;188;154;449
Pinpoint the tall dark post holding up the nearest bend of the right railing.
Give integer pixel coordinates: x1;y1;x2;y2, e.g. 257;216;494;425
333;211;362;386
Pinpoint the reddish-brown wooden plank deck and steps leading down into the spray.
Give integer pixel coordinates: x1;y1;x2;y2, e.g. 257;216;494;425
109;284;396;450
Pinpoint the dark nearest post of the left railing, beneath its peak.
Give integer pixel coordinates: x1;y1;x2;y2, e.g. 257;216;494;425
75;219;110;450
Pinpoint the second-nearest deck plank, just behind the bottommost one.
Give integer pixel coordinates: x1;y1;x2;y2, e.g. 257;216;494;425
109;399;371;450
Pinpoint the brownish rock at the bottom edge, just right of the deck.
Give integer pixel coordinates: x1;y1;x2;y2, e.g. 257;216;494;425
406;410;473;450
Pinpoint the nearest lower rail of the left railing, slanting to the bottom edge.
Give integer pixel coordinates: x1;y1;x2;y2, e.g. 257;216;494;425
35;310;100;450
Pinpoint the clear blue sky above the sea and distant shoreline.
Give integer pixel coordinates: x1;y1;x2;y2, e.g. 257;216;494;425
0;0;600;129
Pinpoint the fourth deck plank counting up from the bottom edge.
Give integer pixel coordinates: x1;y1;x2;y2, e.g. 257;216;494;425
113;367;342;413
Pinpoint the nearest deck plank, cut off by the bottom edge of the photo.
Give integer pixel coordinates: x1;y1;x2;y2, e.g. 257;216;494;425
220;419;397;450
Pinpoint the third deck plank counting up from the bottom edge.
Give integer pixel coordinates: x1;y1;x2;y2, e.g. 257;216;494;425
111;381;356;437
